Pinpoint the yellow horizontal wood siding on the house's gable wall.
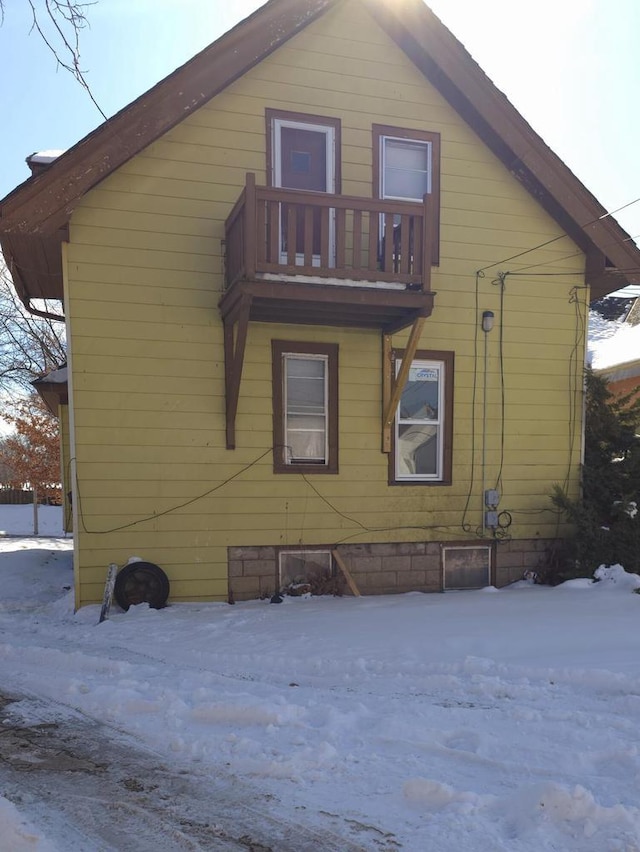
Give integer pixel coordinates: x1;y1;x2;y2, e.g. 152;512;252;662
66;2;587;605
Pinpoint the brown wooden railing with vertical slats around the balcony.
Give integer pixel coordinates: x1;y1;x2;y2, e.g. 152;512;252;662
225;174;434;292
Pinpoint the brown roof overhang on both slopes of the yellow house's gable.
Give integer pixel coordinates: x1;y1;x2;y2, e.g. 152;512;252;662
0;0;640;304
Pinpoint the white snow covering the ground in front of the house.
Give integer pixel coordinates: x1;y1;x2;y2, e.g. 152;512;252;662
0;510;640;852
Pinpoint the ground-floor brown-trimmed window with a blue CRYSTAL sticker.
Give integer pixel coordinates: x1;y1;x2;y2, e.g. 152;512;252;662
390;350;454;485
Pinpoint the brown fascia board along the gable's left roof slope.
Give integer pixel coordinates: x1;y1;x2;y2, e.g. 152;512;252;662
0;0;337;233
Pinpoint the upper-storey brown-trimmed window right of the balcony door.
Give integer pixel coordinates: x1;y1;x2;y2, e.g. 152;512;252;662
372;124;440;266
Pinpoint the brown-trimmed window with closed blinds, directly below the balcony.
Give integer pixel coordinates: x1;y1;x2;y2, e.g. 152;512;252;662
271;340;338;473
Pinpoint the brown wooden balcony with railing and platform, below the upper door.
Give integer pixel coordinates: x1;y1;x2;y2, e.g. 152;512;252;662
220;174;435;333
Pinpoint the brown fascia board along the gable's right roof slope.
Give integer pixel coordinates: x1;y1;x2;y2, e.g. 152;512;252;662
362;0;640;282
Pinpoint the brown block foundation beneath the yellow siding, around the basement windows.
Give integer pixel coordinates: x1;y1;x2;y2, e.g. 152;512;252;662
227;539;553;601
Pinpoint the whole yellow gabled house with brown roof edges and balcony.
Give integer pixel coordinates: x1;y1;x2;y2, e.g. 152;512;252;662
0;0;640;606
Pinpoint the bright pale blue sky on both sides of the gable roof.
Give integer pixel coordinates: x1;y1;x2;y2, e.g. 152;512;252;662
0;0;640;245
